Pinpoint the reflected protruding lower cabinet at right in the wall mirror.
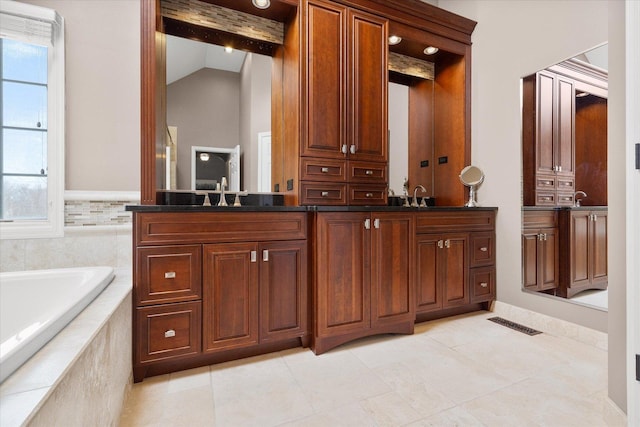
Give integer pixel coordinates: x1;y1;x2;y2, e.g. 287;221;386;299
558;209;608;298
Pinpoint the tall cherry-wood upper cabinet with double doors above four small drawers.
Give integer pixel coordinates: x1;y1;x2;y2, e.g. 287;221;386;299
300;0;388;205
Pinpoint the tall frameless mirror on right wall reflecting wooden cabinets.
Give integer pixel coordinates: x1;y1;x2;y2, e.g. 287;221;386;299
521;44;608;311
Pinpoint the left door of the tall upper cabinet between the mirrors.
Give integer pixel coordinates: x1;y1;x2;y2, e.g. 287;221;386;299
301;0;347;158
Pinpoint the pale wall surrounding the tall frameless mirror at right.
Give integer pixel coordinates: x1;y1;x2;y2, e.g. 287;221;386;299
438;0;625;408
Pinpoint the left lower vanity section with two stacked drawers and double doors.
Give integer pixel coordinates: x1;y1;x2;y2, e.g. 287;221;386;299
133;212;310;381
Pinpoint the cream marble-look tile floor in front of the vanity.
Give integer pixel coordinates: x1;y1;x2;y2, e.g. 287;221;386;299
121;312;625;427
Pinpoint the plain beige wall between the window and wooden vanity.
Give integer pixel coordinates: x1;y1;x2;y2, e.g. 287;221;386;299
25;0;140;191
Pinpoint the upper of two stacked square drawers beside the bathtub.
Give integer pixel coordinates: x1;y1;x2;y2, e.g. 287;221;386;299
135;245;202;306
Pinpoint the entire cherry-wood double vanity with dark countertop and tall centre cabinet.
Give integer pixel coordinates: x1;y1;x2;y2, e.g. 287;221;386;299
128;0;490;381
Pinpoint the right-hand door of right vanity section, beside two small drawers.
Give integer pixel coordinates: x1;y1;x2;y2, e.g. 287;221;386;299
441;235;469;307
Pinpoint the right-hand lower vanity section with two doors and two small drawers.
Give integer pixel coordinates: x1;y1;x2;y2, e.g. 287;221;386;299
416;210;496;320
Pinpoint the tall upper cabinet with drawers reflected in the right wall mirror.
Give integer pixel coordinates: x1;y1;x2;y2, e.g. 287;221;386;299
522;71;575;206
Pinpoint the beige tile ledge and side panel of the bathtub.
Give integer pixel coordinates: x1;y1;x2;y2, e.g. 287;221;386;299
0;269;132;426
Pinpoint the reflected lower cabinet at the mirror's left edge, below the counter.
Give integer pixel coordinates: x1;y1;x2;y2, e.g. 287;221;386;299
522;209;560;293
